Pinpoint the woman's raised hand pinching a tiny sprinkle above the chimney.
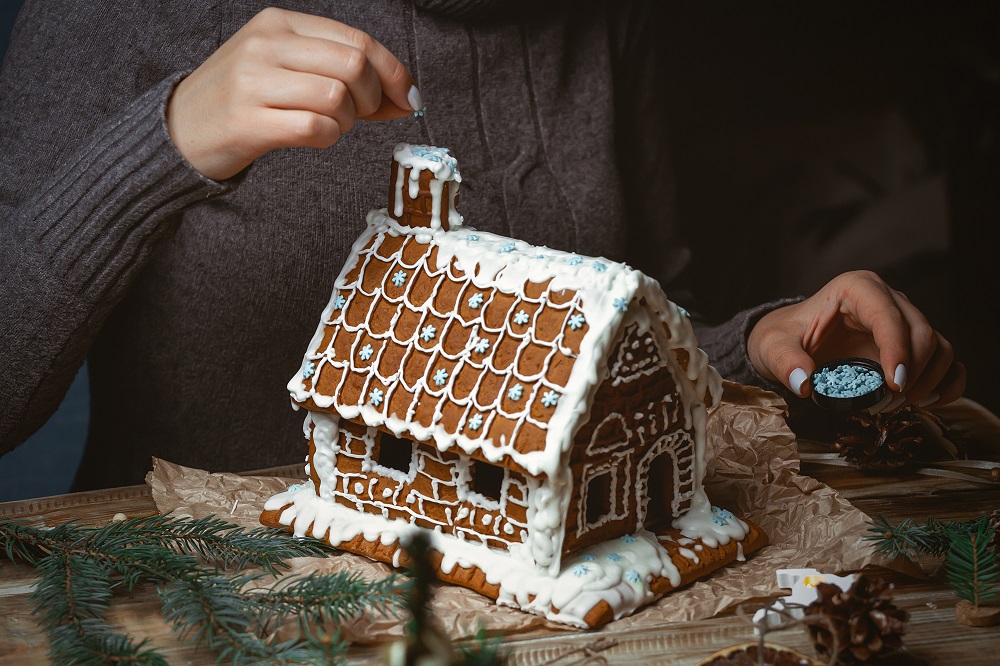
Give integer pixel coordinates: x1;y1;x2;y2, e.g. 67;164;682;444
167;8;422;180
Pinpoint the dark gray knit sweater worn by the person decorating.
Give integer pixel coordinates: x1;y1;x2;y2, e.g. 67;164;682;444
0;0;770;489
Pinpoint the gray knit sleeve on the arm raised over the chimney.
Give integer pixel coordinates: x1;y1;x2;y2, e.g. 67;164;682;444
0;80;231;452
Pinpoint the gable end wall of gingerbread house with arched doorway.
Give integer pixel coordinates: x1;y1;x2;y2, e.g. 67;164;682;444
563;325;695;553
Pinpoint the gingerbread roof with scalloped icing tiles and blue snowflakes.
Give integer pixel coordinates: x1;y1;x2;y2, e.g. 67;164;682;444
288;144;719;476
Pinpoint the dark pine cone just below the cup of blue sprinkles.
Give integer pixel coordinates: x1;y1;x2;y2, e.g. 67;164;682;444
833;406;957;471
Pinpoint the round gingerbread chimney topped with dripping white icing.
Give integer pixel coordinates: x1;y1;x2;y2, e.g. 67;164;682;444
388;143;462;231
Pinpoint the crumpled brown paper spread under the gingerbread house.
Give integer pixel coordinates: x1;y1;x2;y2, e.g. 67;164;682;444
146;382;873;642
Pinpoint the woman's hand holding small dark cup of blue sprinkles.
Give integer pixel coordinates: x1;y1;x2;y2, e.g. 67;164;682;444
747;271;965;411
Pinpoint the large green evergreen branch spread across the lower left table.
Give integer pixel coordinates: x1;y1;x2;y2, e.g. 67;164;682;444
0;514;402;665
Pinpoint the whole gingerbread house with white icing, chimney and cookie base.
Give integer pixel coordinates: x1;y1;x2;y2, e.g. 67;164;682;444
262;144;766;627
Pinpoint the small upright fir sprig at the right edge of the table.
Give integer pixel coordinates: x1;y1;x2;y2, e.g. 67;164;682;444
945;523;1000;608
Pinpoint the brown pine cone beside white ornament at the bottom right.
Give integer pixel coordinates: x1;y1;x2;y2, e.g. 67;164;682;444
806;574;910;663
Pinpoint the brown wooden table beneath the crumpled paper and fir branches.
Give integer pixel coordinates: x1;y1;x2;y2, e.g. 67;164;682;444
0;442;1000;666
